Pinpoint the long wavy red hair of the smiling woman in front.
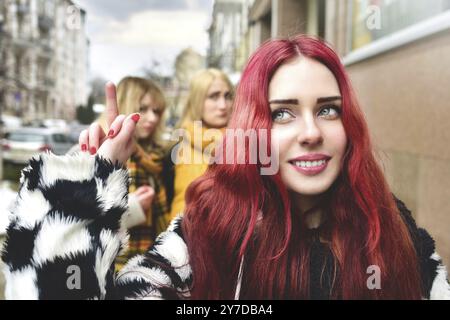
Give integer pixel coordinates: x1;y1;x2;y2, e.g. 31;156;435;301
183;36;421;299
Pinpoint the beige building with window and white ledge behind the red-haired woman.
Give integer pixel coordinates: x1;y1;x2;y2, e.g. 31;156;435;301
208;0;450;265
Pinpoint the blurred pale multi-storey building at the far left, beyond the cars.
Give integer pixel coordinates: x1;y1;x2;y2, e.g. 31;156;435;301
0;0;89;121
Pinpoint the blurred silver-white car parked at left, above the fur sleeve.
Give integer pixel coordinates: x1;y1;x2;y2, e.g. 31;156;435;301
2;128;73;164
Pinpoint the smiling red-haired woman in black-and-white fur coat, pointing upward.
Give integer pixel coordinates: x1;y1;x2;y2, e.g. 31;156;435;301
3;36;450;299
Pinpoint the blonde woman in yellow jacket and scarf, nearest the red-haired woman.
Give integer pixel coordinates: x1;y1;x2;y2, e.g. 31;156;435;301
171;69;233;217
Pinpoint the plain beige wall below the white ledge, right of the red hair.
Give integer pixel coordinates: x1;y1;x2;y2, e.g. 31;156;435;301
347;31;450;266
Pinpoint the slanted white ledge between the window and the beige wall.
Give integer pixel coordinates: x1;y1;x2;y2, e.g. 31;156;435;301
342;10;450;66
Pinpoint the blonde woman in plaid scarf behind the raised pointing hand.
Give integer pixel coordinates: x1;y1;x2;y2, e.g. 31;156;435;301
98;77;169;269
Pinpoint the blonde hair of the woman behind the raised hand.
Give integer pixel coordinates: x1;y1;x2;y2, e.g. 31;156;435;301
98;77;166;145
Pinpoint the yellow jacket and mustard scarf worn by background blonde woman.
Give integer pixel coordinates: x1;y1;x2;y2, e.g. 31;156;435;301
170;121;223;218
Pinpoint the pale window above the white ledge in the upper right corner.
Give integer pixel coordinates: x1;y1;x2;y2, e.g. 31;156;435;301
350;0;450;51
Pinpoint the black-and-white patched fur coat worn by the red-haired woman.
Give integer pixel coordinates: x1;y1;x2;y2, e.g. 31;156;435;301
2;153;450;299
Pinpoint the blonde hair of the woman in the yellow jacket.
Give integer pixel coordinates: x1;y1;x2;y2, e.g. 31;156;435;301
180;68;233;126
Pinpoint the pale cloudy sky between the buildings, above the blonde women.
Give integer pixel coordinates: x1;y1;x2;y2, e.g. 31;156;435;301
74;0;213;83
